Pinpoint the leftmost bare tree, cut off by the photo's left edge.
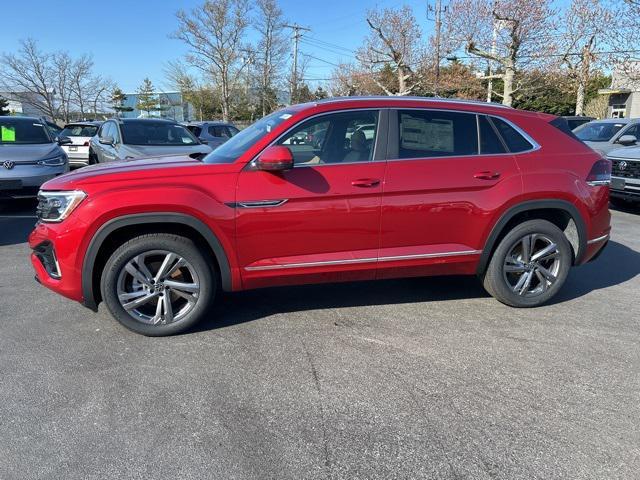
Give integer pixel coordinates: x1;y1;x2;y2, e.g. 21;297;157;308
0;39;58;119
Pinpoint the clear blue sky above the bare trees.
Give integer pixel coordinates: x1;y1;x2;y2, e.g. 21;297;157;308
0;0;568;93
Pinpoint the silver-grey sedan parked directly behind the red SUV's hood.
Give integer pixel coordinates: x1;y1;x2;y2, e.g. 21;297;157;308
89;118;211;163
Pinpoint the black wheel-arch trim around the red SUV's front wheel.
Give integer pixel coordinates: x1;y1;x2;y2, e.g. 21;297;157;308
82;212;231;311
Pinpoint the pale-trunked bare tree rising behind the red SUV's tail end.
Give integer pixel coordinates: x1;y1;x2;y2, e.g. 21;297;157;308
561;0;617;115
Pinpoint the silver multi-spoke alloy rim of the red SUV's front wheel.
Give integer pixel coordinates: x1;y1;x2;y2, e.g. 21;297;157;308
117;250;200;325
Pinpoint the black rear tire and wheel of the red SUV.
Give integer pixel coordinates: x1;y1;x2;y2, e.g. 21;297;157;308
483;220;573;308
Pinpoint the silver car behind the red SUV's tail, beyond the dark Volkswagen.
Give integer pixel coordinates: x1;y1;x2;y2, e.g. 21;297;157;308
573;118;640;155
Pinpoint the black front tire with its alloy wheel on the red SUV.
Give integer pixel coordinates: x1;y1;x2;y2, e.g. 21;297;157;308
100;233;216;337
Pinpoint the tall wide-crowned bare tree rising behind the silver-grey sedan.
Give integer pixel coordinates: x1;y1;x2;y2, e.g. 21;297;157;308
173;0;249;121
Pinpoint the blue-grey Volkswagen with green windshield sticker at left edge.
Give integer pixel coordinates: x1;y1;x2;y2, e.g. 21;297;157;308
0;117;71;198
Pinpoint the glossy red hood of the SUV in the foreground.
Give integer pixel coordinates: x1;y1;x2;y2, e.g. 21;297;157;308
42;155;203;190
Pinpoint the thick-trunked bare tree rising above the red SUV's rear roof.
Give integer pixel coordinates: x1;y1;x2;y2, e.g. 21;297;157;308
447;0;555;105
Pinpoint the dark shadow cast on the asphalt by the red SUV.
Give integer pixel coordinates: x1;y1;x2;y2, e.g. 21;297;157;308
187;242;640;333
